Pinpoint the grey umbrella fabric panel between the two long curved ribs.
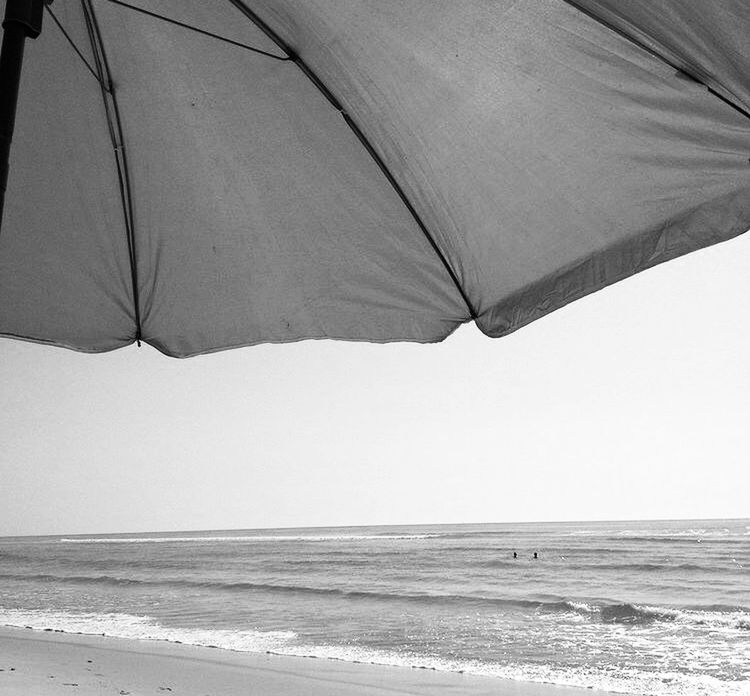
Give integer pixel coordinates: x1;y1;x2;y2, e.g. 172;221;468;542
95;0;469;356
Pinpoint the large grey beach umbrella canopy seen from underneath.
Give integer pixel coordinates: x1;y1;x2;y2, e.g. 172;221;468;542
0;0;750;356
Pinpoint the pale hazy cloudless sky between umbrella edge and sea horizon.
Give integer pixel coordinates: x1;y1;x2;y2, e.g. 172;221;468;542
0;235;750;535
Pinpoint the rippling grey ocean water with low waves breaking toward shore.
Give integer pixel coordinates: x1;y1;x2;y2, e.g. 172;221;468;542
0;520;750;696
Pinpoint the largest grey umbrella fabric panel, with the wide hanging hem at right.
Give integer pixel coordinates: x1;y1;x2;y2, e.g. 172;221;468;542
251;0;750;336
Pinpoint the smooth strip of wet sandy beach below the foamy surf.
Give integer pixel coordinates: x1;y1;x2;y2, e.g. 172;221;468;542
0;627;604;696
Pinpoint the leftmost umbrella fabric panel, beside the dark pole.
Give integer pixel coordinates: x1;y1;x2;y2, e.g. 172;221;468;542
0;2;135;352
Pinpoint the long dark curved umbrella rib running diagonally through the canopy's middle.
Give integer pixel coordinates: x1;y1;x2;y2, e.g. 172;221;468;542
226;0;478;319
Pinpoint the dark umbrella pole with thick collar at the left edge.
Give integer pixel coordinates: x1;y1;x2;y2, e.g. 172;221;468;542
0;0;44;231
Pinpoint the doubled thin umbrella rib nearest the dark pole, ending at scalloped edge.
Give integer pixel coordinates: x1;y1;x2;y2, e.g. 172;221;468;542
81;0;141;346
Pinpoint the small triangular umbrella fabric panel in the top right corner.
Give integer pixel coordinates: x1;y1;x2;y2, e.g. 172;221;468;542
574;0;750;113
